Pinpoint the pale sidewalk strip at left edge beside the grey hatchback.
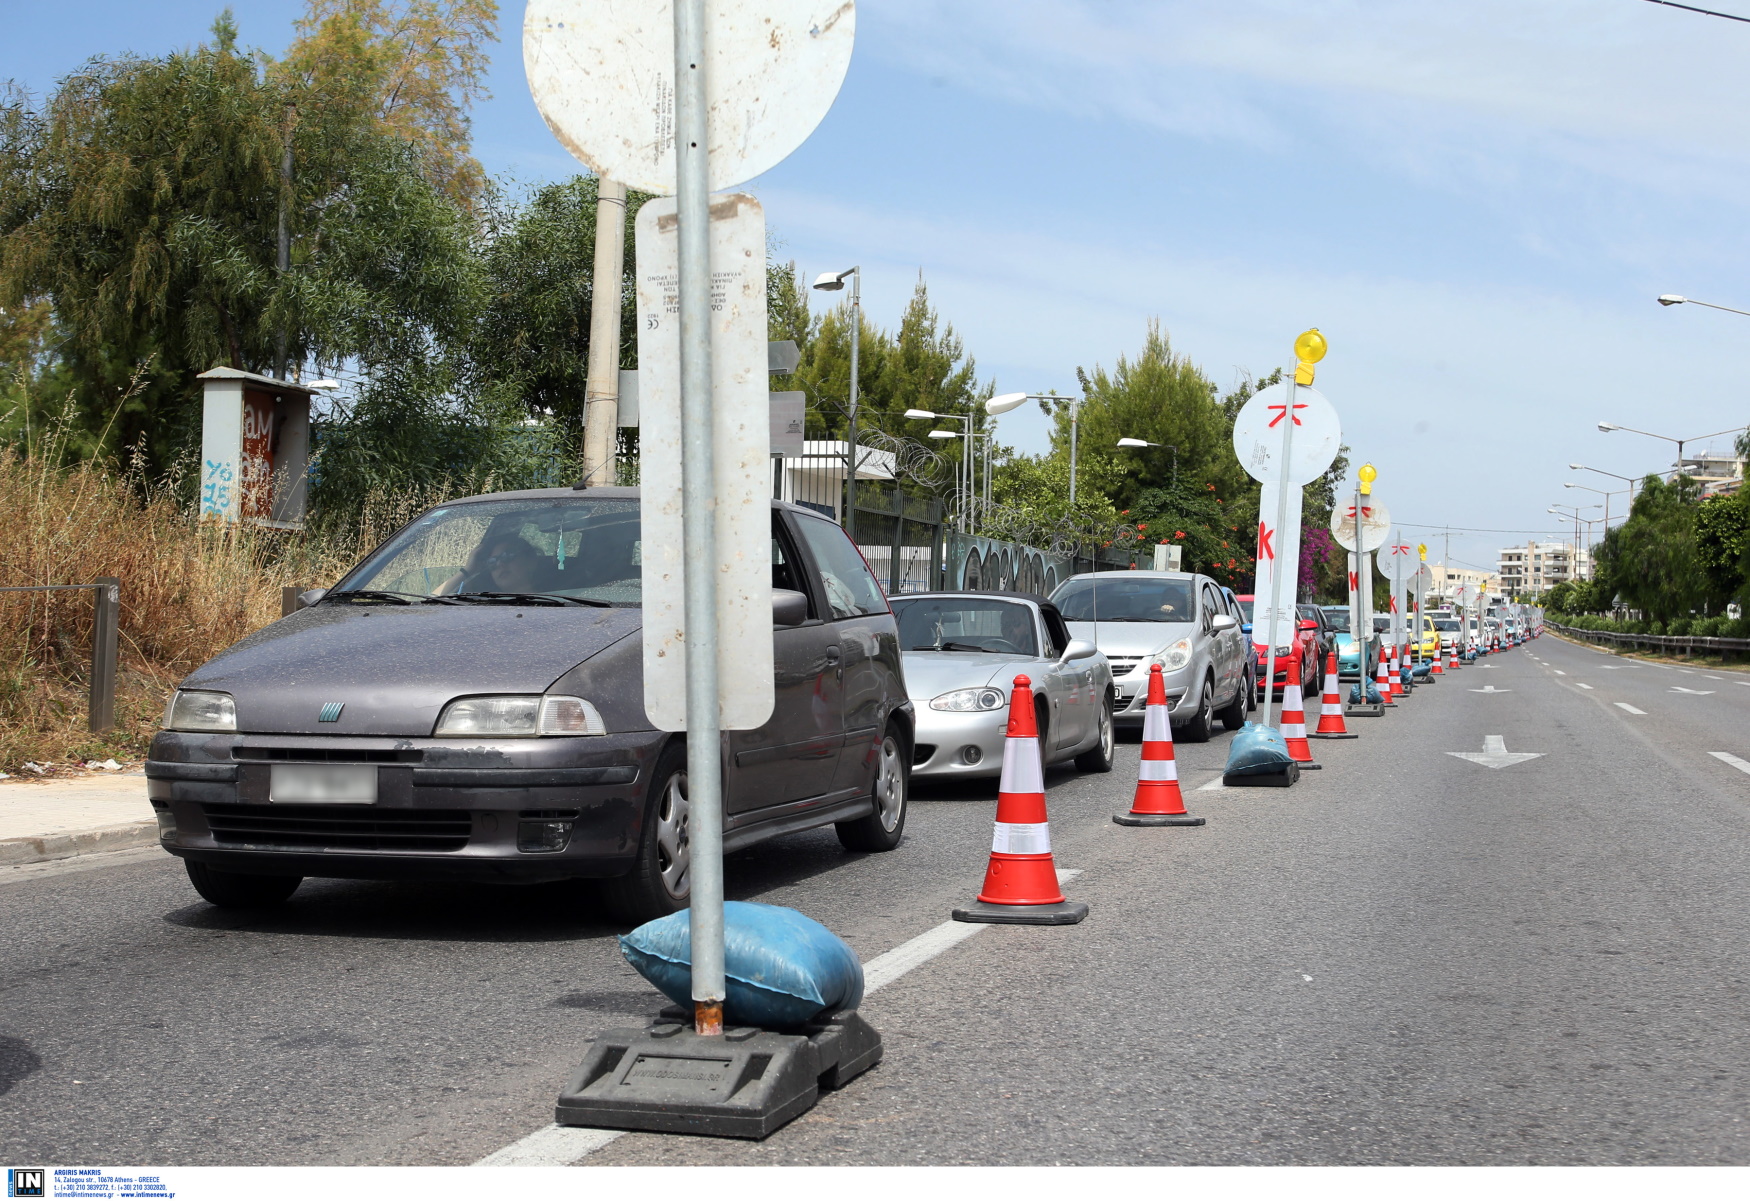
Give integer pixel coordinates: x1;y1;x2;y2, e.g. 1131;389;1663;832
0;769;158;867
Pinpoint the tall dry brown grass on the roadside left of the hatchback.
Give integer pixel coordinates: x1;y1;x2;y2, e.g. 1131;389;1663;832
0;446;458;772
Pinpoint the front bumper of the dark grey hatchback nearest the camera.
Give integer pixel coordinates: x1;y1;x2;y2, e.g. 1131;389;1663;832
145;730;669;882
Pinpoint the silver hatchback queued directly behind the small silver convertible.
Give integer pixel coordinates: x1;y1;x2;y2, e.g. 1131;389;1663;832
1052;571;1253;742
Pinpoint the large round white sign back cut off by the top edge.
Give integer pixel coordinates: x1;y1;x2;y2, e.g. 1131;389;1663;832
523;0;856;196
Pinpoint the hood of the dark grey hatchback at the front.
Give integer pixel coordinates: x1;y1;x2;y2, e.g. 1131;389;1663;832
182;604;644;737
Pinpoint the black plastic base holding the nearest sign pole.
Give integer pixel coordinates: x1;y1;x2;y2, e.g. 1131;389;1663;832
553;1007;882;1138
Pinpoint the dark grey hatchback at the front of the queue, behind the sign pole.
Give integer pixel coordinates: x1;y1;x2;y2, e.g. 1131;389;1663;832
145;488;914;921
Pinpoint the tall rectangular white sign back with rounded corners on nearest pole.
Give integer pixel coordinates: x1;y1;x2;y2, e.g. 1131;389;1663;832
635;193;772;730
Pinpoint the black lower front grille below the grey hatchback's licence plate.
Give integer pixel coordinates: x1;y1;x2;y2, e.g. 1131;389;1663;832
201;805;473;853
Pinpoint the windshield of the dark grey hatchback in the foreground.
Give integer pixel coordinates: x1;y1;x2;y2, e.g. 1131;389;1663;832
329;497;642;608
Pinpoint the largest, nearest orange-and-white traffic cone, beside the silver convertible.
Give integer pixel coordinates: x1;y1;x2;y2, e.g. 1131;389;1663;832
954;676;1089;926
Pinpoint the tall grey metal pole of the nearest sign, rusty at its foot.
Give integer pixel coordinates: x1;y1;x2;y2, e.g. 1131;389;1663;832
674;0;725;1035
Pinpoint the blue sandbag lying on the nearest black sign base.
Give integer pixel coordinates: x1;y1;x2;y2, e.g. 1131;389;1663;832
620;902;863;1029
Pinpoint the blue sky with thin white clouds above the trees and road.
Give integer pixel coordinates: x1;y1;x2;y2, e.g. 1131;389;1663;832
10;0;1750;577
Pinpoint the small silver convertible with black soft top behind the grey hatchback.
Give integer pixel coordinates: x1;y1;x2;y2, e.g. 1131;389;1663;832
891;592;1113;777
